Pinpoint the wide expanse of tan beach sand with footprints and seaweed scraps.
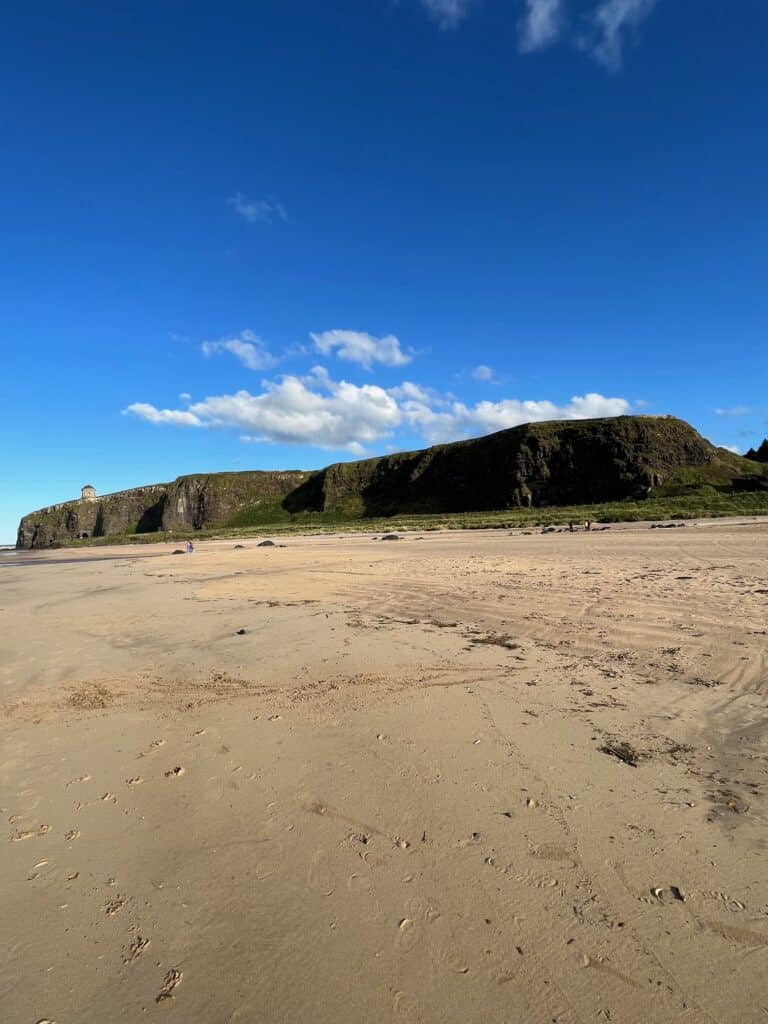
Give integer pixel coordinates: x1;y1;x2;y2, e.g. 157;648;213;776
0;522;768;1024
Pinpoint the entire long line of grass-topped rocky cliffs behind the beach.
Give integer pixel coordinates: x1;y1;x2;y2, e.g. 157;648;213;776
17;416;768;548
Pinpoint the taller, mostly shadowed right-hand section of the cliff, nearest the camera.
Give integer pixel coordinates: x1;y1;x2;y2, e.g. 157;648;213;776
313;417;749;515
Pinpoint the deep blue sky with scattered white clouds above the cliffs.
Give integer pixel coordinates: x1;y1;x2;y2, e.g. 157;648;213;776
0;0;768;541
